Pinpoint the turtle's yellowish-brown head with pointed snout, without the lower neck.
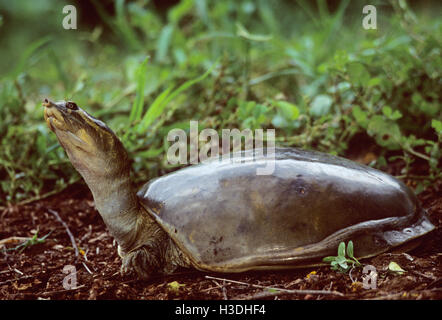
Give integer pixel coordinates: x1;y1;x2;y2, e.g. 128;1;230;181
43;99;130;179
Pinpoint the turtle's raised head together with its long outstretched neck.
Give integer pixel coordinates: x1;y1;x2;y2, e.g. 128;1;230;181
43;99;153;268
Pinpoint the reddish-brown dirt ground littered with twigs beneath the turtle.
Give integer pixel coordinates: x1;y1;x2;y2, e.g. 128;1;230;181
0;170;442;300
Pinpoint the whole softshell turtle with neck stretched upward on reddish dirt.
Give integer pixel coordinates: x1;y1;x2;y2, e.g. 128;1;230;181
43;99;434;278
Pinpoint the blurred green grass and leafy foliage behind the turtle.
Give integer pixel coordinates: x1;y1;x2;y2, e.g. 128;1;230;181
0;0;442;206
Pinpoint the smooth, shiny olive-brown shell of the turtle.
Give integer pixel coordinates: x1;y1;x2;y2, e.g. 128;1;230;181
138;148;434;272
